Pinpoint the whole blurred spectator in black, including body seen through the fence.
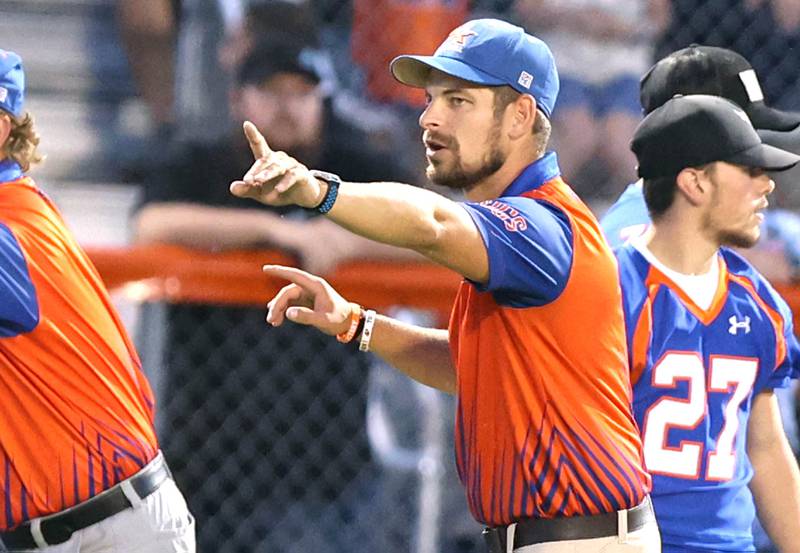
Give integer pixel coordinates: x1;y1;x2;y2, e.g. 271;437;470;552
135;37;424;553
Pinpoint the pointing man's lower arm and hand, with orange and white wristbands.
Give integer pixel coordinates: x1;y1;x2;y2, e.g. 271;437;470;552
264;265;456;393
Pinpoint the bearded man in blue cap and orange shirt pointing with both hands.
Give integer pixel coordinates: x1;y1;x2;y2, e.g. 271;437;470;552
231;19;660;553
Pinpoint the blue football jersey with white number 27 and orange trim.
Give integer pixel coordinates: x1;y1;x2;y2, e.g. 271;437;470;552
617;244;800;553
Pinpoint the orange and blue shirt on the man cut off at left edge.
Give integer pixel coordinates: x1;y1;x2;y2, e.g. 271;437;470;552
0;160;158;531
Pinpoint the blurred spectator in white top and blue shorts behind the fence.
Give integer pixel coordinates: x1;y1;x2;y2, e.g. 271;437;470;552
515;0;669;200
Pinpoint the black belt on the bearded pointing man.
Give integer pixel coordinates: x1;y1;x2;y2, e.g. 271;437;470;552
483;496;655;553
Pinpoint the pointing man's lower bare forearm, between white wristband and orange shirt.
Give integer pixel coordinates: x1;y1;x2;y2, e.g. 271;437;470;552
370;315;456;394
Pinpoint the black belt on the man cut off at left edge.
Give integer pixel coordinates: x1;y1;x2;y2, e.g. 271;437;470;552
0;455;172;551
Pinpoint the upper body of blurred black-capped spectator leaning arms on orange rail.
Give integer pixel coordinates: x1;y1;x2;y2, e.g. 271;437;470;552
135;39;418;272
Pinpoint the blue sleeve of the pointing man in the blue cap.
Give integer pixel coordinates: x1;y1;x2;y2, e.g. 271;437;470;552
462;197;573;307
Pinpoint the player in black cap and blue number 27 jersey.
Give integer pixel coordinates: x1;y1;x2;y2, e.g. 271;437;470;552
616;95;800;553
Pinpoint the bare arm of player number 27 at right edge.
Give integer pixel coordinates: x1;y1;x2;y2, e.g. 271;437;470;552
747;391;800;553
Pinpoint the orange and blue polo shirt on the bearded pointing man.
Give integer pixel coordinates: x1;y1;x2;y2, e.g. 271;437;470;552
450;153;650;526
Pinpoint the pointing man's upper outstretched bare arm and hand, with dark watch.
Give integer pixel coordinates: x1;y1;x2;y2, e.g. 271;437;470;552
231;123;489;282
